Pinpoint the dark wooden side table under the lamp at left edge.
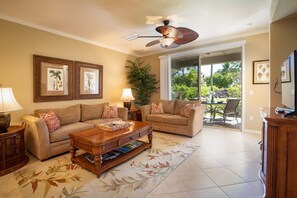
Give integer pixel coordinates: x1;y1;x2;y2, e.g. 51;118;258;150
0;126;29;176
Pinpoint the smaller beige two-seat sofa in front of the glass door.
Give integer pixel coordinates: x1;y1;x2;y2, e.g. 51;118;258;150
141;100;205;137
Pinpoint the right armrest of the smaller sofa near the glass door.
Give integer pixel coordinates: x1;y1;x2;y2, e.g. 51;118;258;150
188;105;205;135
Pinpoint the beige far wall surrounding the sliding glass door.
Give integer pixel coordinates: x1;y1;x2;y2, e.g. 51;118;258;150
142;33;269;131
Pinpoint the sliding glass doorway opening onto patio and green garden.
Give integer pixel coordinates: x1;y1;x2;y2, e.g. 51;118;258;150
170;48;242;130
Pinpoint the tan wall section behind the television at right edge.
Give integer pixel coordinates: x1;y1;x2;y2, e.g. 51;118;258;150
270;13;297;107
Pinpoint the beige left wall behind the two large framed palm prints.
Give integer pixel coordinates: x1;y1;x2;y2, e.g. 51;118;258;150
0;20;134;124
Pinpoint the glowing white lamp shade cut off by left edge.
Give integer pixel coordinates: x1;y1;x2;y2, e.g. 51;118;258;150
0;87;22;112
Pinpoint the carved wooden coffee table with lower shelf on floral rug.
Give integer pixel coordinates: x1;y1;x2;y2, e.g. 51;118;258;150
69;121;153;177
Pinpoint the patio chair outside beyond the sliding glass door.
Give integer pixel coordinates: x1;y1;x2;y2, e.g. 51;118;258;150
213;99;240;124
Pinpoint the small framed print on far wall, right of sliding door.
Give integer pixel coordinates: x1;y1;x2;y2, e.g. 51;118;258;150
253;60;270;84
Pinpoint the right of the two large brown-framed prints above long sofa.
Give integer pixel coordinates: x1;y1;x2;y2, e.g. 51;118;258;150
74;61;103;99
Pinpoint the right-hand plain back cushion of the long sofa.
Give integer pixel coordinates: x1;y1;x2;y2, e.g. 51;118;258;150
81;103;108;121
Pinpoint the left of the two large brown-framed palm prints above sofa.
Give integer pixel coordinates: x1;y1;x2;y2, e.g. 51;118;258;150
33;55;74;102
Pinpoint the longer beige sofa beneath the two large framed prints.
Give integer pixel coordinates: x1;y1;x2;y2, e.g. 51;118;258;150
22;103;128;160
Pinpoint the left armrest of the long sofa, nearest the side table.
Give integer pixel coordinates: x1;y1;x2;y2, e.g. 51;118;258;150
22;115;50;159
